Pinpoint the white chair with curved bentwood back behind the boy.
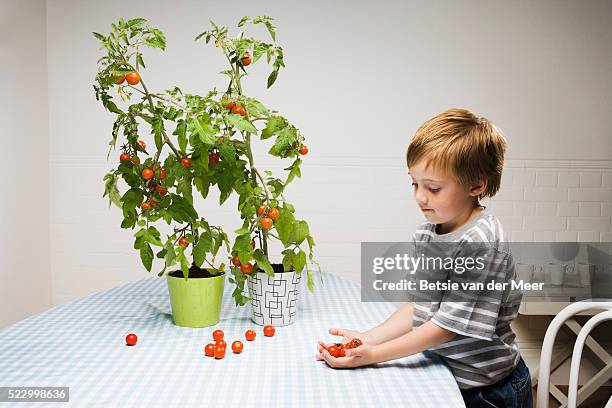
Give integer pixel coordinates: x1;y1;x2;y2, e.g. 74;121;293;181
537;299;612;408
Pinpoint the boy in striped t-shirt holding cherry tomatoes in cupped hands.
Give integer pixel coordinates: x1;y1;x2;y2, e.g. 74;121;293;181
316;109;531;407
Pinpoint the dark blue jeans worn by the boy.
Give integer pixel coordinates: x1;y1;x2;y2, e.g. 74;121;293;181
461;357;531;408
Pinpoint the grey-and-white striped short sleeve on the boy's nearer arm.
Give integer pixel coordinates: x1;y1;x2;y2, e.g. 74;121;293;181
431;243;512;340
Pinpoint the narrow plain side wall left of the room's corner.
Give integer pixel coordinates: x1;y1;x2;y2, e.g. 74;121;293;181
0;0;51;328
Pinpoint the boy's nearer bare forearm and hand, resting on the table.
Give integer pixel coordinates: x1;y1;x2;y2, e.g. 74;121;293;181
321;320;455;368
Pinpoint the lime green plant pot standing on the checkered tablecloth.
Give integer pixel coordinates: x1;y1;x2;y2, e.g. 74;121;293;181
166;274;225;327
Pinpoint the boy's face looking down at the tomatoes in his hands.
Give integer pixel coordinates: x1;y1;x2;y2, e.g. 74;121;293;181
408;160;483;233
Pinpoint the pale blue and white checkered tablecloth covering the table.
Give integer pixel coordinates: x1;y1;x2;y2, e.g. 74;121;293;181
0;273;464;408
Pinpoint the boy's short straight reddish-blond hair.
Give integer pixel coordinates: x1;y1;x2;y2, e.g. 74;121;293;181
406;109;507;198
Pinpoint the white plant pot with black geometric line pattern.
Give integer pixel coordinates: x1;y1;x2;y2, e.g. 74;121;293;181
248;272;302;326
